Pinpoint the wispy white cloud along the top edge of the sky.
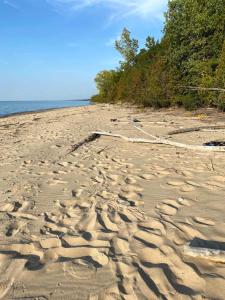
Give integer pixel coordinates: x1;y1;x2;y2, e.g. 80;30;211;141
46;0;168;19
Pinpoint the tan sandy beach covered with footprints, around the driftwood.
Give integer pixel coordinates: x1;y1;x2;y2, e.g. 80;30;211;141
0;105;225;300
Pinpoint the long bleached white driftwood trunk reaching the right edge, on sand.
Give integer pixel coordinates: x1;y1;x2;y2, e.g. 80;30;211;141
93;128;225;152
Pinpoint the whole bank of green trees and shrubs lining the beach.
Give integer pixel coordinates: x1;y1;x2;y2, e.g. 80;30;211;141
91;0;225;111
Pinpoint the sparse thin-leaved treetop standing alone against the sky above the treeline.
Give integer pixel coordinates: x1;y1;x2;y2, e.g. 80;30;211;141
115;28;139;69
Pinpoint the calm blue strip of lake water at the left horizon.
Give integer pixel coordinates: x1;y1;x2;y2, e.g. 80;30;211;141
0;100;90;117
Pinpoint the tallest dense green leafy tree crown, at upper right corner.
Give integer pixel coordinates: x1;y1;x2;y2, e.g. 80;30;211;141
164;0;225;85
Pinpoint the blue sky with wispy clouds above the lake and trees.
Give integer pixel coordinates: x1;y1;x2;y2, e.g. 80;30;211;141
0;0;167;100
